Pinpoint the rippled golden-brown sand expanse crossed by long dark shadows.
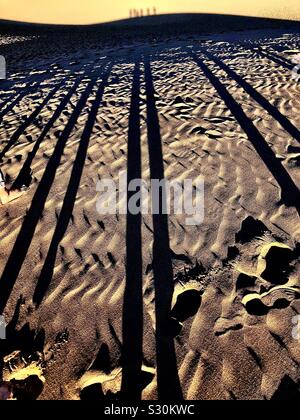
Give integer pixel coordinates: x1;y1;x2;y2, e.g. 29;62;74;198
0;15;300;400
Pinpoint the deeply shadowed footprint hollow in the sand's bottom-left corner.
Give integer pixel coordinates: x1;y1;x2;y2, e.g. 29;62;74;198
0;296;69;401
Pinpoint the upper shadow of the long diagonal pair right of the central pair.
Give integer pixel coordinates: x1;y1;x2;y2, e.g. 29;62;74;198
201;49;300;142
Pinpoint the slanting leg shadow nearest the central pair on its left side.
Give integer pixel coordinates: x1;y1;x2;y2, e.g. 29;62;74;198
33;64;112;306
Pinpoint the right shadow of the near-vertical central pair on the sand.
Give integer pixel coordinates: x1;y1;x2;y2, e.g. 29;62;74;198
144;57;183;401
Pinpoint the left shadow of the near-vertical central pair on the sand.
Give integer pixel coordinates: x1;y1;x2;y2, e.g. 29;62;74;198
122;61;143;400
